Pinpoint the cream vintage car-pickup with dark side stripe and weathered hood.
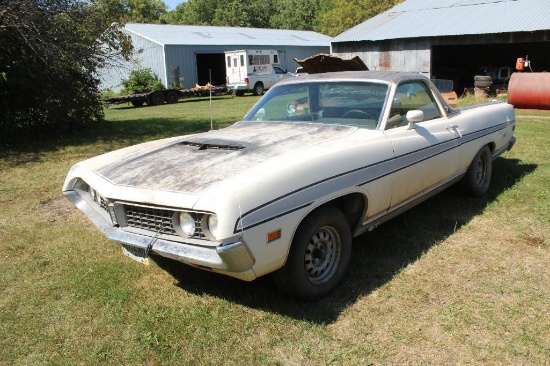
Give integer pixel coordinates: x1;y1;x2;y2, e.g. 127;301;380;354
63;71;515;299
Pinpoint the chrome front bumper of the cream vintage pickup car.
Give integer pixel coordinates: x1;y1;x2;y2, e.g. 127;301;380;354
63;191;256;281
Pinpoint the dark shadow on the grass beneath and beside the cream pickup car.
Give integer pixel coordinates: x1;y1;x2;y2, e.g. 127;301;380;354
154;158;536;324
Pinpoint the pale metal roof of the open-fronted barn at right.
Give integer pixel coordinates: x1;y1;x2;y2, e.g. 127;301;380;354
332;0;550;42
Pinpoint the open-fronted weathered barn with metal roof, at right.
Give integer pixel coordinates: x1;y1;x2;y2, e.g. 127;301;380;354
331;0;550;93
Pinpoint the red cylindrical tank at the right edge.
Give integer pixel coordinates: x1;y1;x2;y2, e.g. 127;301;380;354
508;72;550;109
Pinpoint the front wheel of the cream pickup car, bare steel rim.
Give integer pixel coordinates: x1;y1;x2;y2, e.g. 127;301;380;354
273;207;352;301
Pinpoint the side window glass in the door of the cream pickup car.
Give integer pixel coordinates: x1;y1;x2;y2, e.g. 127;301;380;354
386;81;442;129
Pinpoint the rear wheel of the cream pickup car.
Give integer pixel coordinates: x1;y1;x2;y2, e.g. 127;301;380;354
459;146;493;198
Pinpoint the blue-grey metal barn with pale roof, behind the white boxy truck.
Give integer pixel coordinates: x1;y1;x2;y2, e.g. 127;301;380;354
101;24;331;90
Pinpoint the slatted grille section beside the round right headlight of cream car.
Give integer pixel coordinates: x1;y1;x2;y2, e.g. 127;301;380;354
124;205;176;235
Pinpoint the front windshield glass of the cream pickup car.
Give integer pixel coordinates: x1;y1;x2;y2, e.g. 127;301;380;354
244;81;389;129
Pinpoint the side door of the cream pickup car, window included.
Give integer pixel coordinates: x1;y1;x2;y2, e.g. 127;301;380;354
385;80;460;208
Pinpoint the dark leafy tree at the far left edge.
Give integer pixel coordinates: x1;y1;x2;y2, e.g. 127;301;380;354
0;0;131;139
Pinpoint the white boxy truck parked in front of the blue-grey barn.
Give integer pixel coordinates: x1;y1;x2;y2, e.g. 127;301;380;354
225;50;295;96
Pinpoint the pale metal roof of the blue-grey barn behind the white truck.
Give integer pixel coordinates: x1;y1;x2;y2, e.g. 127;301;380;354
125;23;331;47
